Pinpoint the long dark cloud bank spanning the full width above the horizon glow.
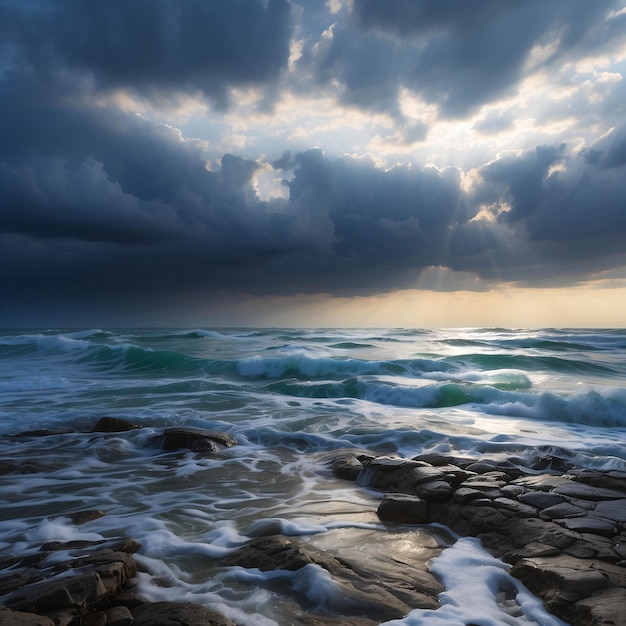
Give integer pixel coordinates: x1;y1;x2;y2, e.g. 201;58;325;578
0;122;626;310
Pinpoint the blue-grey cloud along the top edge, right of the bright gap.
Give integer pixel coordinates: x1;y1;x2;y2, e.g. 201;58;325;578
302;0;623;116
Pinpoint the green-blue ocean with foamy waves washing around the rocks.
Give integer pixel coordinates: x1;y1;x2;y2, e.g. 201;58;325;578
0;328;626;626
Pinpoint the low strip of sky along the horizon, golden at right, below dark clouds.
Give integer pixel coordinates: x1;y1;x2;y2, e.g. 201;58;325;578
6;285;626;329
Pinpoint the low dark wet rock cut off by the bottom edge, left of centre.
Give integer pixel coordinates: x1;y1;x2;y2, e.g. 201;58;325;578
132;602;235;626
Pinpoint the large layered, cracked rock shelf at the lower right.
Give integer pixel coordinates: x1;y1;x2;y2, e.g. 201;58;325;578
330;450;626;626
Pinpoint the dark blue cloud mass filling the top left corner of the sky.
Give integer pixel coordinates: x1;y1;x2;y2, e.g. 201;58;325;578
0;0;293;106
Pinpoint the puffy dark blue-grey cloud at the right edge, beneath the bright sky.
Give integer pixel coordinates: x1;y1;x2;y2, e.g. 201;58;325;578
477;135;626;250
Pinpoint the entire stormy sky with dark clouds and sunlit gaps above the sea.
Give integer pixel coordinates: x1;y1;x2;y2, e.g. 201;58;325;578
0;0;626;327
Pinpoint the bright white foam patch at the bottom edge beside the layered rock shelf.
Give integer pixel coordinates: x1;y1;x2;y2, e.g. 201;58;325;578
385;538;567;626
